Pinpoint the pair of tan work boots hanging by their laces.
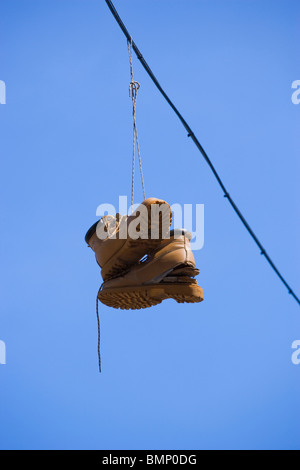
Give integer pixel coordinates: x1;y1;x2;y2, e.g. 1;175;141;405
85;198;203;310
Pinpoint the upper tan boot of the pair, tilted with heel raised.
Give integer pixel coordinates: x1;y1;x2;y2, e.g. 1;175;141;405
85;198;172;281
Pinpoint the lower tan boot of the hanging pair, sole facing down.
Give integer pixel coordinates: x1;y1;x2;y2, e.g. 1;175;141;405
98;230;203;310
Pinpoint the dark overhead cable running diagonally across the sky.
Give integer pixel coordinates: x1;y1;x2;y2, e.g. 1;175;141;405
105;0;300;305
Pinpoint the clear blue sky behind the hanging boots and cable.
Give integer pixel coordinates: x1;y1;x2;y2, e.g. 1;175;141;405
0;0;300;450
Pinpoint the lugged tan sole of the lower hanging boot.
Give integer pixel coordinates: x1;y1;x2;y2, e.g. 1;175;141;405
98;283;203;310
